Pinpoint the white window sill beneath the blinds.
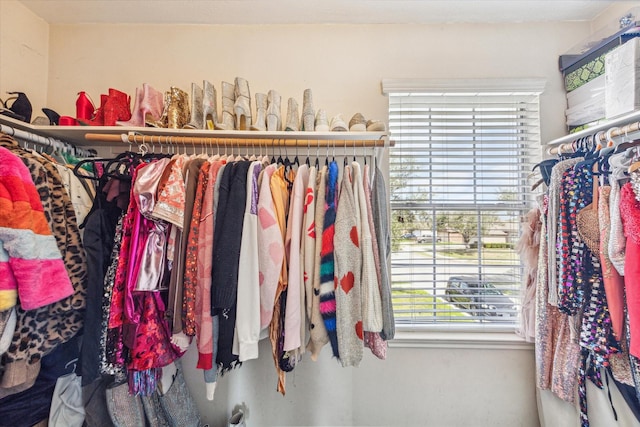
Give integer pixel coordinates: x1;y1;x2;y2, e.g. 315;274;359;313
389;325;534;350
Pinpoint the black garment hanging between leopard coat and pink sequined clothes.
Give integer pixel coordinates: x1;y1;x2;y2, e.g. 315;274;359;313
80;189;122;386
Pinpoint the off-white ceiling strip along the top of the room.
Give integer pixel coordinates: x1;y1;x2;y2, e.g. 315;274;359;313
21;0;615;24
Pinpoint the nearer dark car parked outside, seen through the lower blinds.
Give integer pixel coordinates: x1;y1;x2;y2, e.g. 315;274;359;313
445;275;518;318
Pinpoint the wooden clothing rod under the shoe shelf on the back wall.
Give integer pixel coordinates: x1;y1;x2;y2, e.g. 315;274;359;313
85;132;395;148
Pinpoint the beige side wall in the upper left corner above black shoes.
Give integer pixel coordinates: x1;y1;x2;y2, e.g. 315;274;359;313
0;0;49;120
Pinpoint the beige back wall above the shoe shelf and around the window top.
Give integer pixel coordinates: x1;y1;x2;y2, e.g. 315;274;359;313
48;23;589;145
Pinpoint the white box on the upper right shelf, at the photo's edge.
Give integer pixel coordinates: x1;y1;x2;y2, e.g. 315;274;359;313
605;38;640;119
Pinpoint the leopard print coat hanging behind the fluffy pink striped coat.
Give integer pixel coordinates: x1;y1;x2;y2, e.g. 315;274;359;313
0;136;87;398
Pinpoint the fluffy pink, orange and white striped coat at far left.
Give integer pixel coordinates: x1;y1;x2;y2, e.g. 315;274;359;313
0;147;73;311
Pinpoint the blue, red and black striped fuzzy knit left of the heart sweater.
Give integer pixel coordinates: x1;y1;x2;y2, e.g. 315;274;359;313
320;162;340;358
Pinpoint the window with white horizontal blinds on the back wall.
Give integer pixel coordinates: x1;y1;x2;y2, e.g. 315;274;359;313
383;80;543;329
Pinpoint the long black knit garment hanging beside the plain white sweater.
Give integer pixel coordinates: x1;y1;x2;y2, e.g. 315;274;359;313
211;161;251;373
